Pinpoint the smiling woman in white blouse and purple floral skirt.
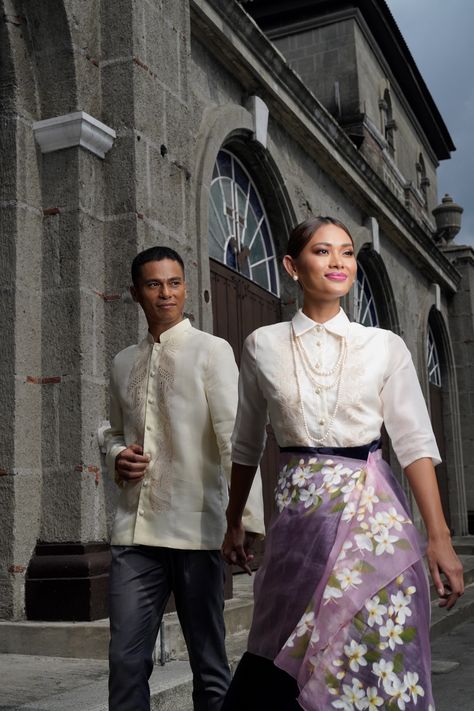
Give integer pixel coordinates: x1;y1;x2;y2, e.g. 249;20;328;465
223;217;464;711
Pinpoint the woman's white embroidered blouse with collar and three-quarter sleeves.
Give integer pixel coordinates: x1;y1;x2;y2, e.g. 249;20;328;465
232;310;441;467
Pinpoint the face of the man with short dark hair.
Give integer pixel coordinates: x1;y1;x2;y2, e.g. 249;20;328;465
130;259;186;332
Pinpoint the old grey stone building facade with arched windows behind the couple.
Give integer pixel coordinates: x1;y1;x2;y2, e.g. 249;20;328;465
0;0;474;619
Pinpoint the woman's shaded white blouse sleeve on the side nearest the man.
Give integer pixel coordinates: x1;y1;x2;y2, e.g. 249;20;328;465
232;331;267;466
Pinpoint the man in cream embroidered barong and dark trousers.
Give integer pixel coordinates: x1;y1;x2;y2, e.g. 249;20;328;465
106;247;263;711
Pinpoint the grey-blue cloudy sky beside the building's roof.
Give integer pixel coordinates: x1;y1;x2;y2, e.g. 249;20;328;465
386;0;474;247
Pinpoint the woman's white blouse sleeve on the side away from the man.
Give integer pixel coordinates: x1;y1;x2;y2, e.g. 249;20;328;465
381;333;441;468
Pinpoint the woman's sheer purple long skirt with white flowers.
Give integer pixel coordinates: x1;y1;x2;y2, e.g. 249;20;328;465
248;447;434;711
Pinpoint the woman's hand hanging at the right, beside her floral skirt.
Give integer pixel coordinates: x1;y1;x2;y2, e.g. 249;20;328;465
426;531;464;610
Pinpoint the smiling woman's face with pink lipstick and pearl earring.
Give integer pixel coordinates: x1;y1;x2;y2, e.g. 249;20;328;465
285;224;357;302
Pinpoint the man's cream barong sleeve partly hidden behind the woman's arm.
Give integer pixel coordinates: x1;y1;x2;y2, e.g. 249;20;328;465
206;340;265;533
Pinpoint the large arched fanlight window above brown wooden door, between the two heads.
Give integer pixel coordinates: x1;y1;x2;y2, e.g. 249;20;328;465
209;149;280;296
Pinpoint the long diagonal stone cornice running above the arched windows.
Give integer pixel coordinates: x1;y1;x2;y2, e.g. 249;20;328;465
190;0;461;292
